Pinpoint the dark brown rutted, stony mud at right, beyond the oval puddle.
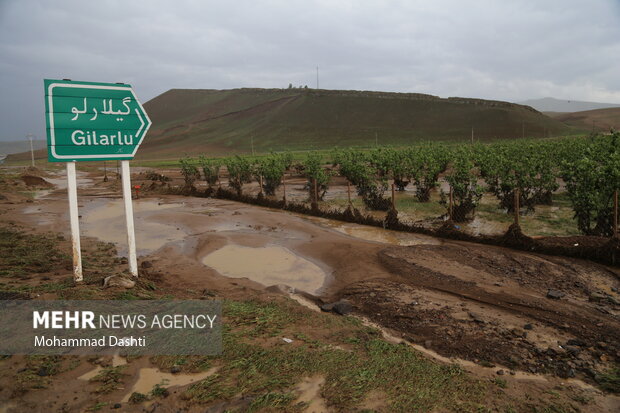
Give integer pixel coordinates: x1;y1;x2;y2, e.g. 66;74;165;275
339;243;620;379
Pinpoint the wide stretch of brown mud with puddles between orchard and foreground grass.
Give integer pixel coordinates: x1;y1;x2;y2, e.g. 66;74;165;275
6;166;620;411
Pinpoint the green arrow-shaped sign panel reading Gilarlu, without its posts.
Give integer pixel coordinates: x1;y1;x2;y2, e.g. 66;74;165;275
45;79;151;162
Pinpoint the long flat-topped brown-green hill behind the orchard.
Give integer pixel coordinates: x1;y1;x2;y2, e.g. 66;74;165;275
138;89;575;157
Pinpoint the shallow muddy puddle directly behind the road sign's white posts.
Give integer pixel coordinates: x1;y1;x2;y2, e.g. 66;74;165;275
80;199;186;255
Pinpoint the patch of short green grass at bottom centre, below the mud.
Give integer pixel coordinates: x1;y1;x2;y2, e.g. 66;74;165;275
182;301;484;411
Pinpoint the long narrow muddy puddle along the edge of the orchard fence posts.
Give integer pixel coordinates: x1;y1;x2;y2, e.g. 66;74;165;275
303;217;443;247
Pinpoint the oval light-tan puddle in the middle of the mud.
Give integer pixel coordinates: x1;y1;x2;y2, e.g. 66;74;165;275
202;245;327;294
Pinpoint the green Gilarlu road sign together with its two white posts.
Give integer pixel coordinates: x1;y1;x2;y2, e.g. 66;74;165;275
44;79;151;281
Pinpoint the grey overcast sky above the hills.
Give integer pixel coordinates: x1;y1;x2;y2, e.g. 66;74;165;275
0;0;620;140
